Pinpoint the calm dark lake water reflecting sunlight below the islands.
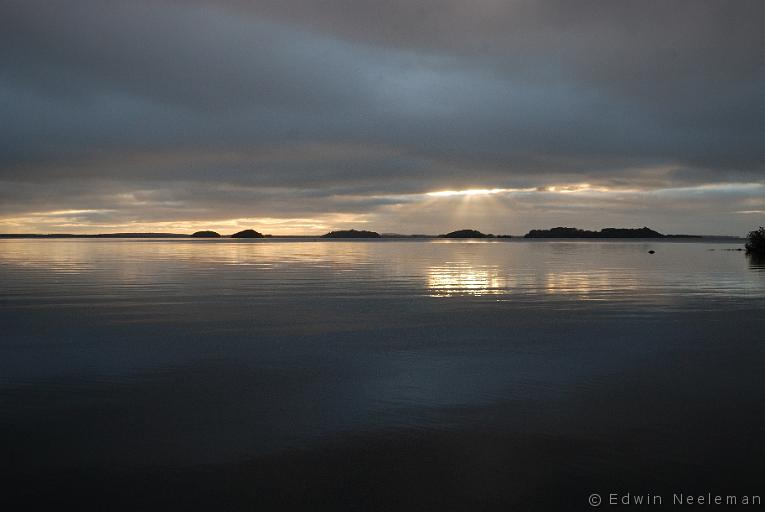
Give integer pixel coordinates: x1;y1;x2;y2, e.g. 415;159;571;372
0;239;765;511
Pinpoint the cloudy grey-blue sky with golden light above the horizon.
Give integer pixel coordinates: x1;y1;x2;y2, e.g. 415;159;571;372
0;0;765;235
